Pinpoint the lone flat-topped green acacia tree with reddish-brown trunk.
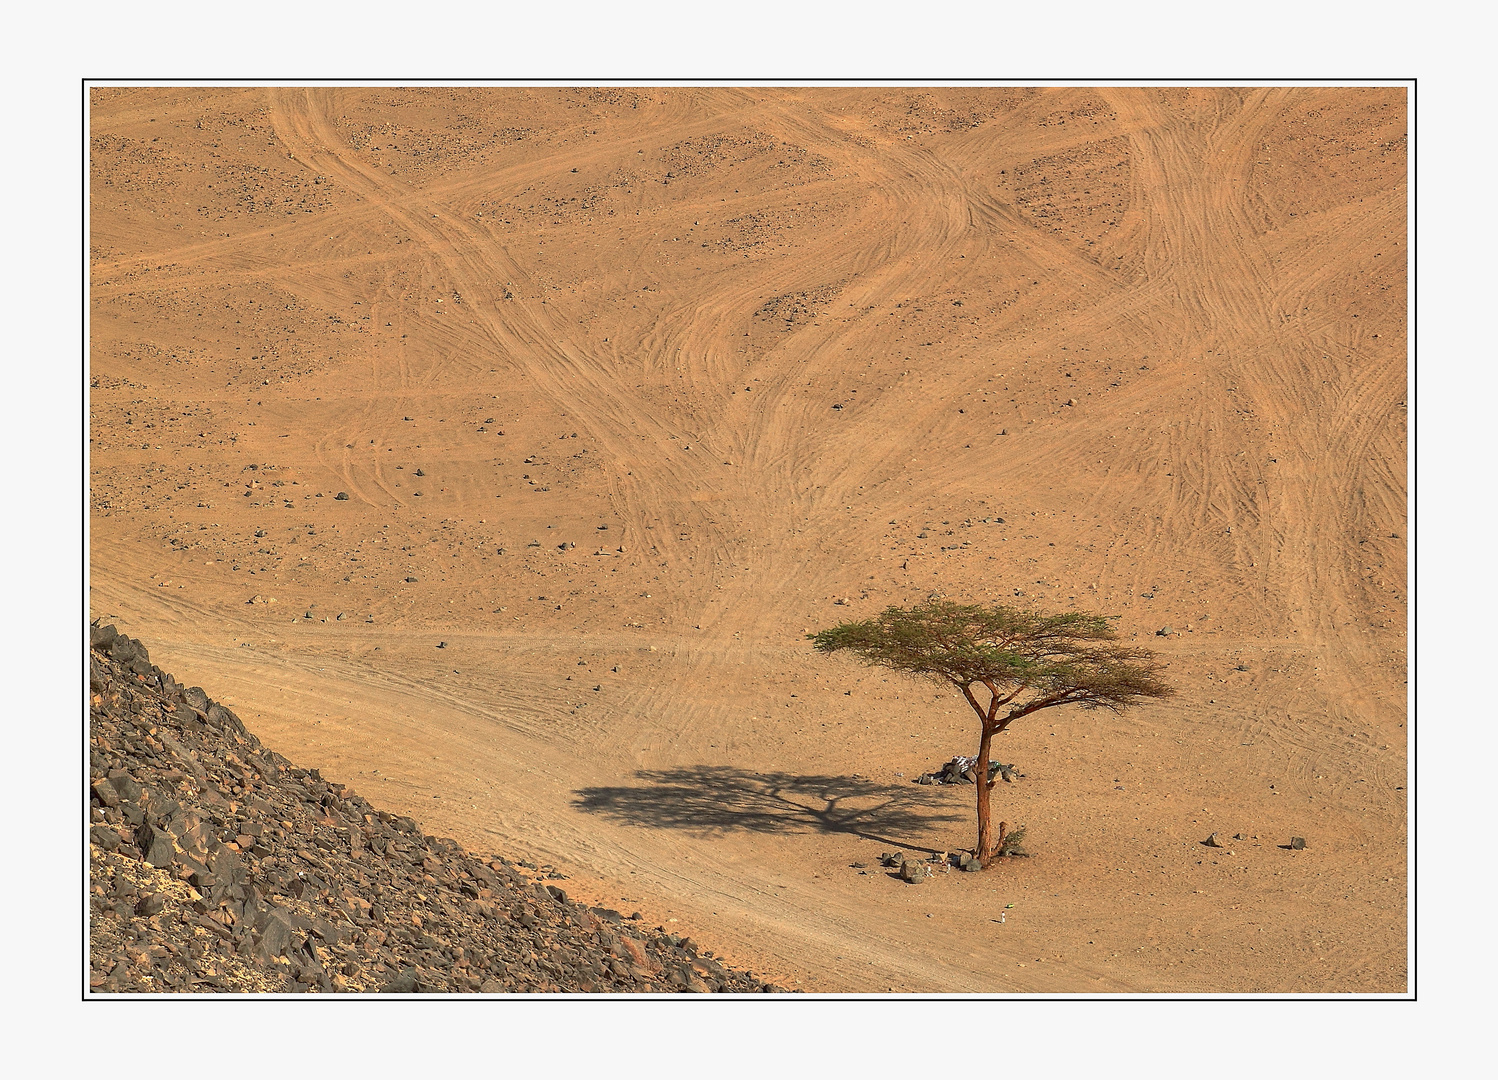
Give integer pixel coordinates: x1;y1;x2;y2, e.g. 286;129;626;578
806;601;1174;867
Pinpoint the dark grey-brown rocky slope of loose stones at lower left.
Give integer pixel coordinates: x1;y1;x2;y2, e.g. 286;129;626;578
88;623;780;993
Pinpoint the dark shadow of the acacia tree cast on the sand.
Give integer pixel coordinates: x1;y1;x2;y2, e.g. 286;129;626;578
574;765;962;851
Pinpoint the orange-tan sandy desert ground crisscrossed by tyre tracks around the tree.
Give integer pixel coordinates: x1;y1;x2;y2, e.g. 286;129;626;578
90;88;1407;993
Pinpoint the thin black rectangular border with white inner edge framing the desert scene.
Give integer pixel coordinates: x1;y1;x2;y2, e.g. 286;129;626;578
79;76;1420;1004
